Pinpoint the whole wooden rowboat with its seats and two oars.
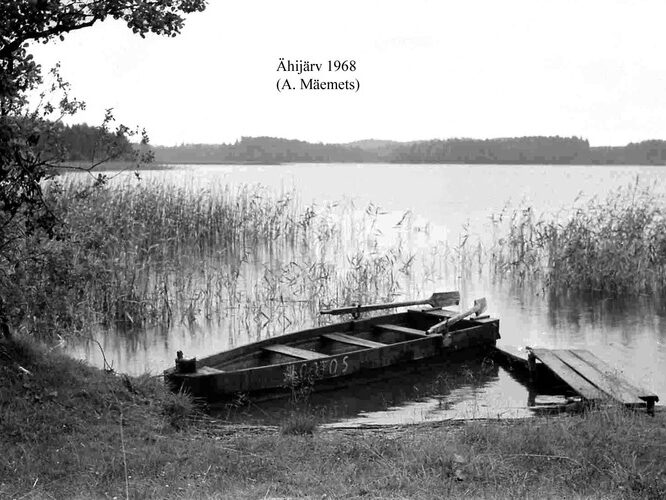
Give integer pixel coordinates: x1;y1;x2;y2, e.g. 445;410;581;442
164;292;500;400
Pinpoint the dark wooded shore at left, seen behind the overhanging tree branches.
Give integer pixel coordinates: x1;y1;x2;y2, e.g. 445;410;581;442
58;123;133;162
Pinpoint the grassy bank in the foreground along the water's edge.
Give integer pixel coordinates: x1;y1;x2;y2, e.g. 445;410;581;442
0;341;666;499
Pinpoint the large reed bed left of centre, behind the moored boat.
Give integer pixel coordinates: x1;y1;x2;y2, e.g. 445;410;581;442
21;178;460;336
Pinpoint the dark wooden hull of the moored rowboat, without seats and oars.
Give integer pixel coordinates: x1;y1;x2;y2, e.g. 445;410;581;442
165;311;499;400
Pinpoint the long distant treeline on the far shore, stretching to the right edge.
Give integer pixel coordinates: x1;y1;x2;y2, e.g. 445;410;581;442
154;137;666;165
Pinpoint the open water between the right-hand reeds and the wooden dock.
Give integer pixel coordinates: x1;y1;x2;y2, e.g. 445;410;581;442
486;286;666;402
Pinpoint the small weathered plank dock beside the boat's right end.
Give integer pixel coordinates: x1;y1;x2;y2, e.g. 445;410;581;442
528;348;659;414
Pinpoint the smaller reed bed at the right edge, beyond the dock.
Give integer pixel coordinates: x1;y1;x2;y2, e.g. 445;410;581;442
487;179;666;294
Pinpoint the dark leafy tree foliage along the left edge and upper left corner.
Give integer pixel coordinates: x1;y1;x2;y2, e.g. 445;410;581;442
0;0;206;336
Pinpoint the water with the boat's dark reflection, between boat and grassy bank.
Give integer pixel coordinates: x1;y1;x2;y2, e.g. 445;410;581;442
213;357;531;427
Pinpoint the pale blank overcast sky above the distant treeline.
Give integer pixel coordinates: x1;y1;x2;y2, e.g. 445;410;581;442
33;0;666;145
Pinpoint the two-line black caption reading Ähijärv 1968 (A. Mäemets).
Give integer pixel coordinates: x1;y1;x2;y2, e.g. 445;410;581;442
275;57;361;92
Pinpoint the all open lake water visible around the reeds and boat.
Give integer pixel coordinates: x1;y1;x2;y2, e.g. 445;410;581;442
66;164;666;425
